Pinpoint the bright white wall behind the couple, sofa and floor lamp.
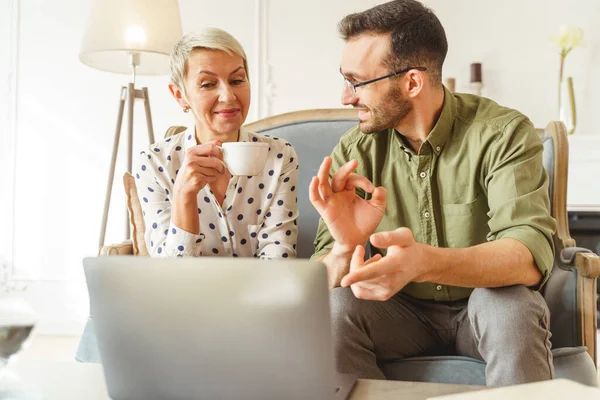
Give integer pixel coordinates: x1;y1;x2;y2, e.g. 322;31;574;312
0;0;600;333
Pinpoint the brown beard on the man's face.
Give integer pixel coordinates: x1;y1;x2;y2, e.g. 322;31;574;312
355;88;413;133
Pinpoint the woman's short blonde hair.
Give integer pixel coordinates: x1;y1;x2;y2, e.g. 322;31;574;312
169;28;248;93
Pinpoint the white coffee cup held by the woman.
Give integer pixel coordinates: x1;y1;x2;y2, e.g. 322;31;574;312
220;142;269;176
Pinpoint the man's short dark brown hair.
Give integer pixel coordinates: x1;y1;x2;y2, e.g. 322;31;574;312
338;0;448;85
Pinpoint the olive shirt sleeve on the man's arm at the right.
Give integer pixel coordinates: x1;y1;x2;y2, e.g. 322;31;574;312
485;120;556;288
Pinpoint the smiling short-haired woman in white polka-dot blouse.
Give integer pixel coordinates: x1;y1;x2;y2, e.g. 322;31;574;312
134;28;298;258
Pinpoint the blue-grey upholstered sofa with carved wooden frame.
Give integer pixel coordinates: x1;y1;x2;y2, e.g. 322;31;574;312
77;109;600;386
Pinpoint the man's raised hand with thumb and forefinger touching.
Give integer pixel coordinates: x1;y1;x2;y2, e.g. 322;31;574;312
309;157;387;257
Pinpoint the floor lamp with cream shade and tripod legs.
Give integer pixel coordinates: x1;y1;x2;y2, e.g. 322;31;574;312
79;0;181;247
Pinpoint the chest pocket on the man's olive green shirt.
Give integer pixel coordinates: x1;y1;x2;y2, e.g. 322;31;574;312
443;194;489;248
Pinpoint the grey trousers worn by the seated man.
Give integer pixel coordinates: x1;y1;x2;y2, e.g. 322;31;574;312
330;285;554;386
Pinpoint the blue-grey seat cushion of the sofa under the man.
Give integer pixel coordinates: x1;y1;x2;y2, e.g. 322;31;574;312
382;347;598;386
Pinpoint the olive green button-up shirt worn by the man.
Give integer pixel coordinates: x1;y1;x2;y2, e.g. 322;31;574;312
313;90;555;301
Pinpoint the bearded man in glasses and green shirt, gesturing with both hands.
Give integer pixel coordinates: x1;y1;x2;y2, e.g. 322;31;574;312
310;0;555;385
